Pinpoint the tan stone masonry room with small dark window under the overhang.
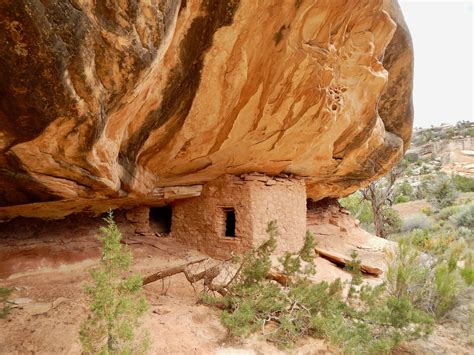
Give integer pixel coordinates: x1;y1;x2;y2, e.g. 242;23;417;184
171;174;306;258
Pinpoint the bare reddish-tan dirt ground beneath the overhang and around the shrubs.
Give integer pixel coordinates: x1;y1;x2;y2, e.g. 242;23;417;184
0;211;472;354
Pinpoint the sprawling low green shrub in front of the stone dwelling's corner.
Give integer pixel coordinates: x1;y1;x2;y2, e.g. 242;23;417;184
202;222;432;354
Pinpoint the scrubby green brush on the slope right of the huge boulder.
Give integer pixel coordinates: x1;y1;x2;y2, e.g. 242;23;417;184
339;122;474;354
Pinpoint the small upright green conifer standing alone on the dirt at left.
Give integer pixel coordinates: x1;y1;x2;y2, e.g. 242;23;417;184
80;212;148;354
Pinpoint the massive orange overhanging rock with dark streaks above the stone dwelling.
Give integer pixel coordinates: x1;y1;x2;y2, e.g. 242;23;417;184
0;0;412;217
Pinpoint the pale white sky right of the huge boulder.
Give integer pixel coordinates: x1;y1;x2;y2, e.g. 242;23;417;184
399;0;474;127
